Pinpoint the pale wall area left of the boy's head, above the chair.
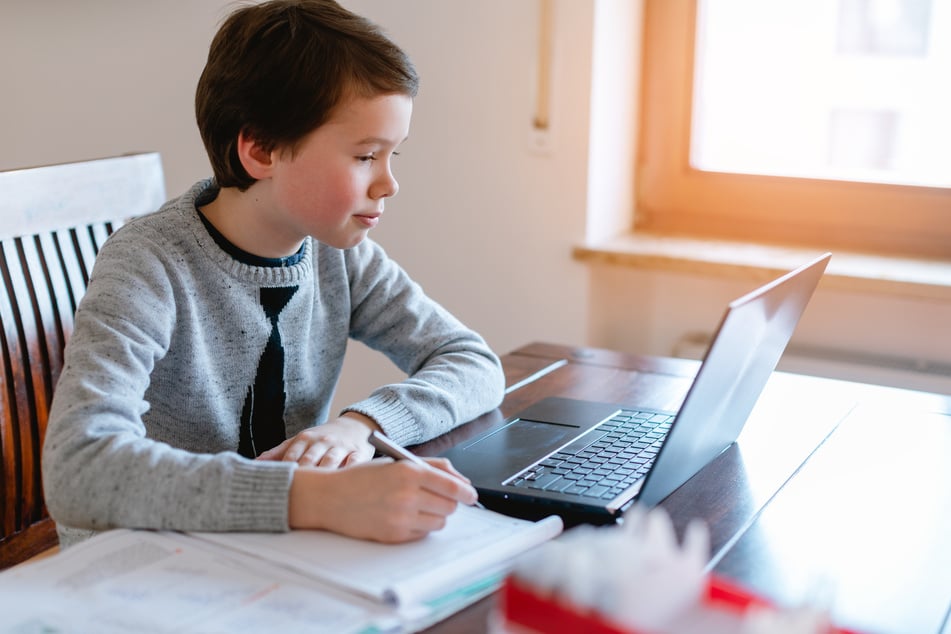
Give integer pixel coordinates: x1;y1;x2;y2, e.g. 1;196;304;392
0;0;219;195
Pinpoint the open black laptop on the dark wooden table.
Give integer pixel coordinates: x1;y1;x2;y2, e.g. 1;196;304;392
442;253;831;526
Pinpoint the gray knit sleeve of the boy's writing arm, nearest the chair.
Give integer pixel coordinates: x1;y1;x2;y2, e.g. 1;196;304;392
43;230;294;531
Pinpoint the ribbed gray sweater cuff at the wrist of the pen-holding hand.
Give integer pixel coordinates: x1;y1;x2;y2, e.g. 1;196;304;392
227;460;297;532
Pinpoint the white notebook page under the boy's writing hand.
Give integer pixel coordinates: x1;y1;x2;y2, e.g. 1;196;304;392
193;506;563;606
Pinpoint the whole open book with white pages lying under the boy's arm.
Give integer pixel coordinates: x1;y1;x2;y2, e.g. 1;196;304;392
0;506;563;634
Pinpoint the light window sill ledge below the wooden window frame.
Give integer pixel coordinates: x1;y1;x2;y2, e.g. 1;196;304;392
573;233;951;301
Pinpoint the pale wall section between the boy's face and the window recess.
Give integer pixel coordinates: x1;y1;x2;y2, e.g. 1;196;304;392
341;0;592;404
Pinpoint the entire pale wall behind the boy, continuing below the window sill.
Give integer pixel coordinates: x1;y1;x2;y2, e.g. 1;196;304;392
0;0;951;401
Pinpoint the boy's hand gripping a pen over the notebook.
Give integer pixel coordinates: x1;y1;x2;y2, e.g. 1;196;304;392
288;458;477;543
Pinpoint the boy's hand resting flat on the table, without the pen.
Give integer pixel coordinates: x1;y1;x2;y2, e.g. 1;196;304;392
257;412;380;468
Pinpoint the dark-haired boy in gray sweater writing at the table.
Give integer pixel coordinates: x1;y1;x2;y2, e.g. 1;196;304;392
43;0;503;545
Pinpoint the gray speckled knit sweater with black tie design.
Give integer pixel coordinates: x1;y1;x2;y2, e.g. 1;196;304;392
43;181;503;545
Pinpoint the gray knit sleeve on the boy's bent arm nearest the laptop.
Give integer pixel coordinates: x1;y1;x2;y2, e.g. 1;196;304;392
345;240;505;445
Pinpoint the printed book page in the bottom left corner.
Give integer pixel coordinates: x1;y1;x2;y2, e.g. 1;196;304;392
0;530;398;634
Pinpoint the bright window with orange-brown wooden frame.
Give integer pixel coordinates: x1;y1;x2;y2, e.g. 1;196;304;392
635;0;951;259
